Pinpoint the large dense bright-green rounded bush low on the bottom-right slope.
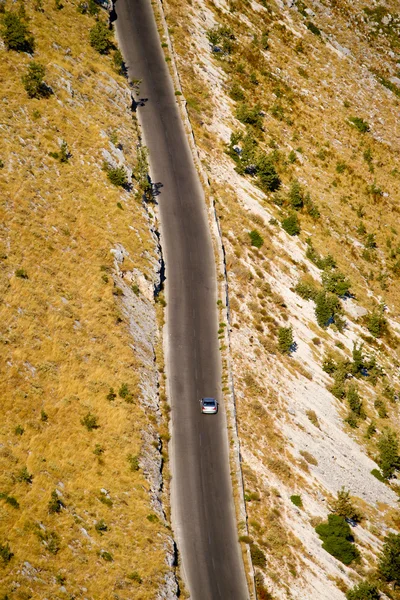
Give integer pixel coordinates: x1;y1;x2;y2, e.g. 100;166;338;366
315;514;359;565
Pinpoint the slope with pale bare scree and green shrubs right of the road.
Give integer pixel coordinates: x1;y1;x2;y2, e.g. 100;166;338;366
155;0;400;600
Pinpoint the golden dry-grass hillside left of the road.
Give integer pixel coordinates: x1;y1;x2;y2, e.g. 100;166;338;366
0;0;176;600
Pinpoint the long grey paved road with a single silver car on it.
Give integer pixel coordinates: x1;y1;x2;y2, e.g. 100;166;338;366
115;0;248;600
